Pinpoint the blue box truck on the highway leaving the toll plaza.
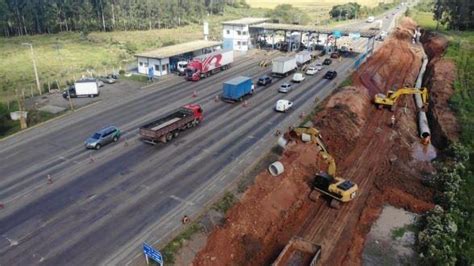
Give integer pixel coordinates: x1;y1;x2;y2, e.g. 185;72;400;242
221;76;254;102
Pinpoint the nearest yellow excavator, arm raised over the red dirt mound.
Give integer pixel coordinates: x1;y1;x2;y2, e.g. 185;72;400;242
293;127;359;208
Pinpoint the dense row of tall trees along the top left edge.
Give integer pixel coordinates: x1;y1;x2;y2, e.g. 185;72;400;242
0;0;247;36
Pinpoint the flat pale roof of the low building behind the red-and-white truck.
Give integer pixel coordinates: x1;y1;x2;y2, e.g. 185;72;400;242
135;40;222;59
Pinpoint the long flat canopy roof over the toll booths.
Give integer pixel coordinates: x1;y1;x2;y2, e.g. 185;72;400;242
249;22;377;38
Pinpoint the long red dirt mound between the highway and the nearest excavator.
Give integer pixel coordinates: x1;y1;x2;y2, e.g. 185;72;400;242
193;143;318;265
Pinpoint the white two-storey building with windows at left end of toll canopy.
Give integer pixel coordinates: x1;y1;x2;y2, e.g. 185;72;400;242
222;18;270;51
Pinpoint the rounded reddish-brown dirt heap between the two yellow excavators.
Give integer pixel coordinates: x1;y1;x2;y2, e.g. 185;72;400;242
313;87;371;159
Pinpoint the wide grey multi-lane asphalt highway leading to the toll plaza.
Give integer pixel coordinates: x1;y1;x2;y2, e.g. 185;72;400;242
0;7;404;265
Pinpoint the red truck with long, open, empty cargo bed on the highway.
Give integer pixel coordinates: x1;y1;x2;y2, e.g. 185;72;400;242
139;104;203;145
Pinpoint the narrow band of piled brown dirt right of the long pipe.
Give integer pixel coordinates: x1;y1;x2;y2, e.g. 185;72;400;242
422;33;460;147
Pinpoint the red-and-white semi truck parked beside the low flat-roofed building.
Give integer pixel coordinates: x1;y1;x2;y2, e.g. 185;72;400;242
185;50;234;81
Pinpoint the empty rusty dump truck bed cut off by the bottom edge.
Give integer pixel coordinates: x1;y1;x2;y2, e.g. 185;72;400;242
272;237;321;266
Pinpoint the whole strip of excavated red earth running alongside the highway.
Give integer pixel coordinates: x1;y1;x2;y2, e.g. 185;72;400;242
187;18;459;265
